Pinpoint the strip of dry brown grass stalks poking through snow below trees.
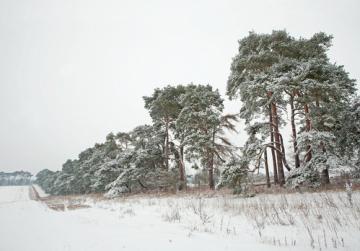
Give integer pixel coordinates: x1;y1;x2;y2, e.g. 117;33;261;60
40;188;360;250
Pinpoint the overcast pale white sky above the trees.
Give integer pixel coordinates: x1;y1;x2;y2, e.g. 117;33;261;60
0;0;360;173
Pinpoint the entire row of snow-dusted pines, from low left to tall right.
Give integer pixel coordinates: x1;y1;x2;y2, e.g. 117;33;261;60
37;31;360;195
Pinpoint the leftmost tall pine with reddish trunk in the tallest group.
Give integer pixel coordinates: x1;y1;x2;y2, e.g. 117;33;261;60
227;31;292;185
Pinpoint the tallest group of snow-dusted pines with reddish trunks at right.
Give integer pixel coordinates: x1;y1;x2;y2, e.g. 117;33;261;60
227;31;360;186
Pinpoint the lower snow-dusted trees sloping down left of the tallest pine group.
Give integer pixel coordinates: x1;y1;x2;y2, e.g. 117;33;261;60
37;84;237;196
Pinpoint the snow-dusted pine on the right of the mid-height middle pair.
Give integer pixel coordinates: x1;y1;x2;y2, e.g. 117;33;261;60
176;84;224;189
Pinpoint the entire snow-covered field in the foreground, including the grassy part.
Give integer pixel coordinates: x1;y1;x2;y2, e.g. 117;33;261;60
0;186;360;251
